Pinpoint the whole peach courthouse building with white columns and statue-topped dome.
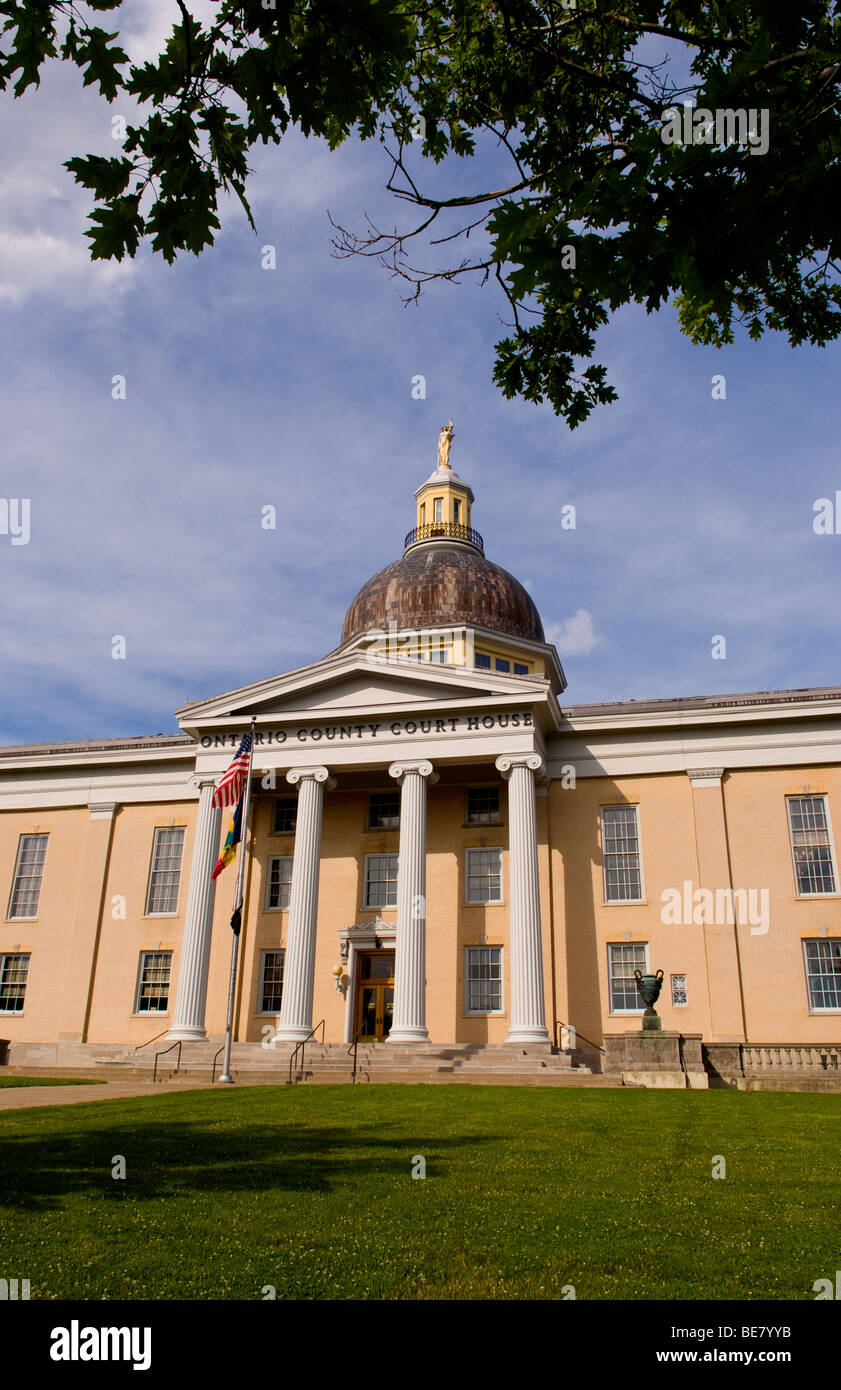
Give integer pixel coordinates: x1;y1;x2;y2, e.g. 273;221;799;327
0;430;841;1066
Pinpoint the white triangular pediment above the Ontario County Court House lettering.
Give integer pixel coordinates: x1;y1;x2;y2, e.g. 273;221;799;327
177;651;548;730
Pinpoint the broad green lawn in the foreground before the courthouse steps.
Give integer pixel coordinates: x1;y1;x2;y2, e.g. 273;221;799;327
0;1086;841;1300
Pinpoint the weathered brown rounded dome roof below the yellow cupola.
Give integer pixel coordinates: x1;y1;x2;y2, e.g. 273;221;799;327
342;545;545;645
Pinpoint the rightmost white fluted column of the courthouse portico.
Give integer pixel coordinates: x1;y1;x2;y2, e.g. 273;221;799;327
496;753;549;1043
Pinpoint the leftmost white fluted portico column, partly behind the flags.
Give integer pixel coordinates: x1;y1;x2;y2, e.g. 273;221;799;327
167;777;222;1043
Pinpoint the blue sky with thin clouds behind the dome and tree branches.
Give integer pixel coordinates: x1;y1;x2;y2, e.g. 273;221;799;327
0;0;841;744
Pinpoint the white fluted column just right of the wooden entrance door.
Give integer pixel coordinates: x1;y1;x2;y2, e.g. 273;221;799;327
388;759;438;1043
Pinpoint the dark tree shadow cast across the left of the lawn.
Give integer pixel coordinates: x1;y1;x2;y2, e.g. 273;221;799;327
0;1116;498;1212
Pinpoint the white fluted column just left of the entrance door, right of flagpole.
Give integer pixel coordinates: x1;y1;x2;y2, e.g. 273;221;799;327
275;767;335;1043
